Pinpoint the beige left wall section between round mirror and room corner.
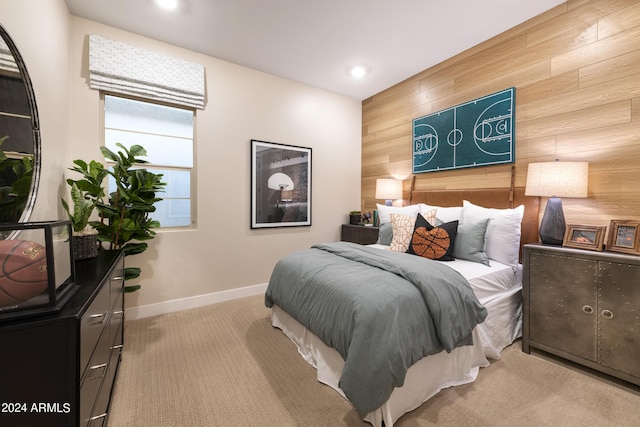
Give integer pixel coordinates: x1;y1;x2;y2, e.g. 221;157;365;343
0;0;71;220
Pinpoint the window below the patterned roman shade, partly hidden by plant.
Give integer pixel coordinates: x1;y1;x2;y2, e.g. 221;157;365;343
104;95;195;228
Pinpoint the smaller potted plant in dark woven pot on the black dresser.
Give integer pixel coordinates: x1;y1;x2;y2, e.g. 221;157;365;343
60;160;107;260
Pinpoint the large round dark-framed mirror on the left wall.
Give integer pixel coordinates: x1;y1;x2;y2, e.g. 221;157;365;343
0;25;41;227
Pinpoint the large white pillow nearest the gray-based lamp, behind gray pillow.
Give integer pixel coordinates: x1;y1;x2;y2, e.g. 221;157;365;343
462;200;524;265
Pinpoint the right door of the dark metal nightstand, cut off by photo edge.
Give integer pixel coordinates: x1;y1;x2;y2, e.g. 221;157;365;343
598;262;640;378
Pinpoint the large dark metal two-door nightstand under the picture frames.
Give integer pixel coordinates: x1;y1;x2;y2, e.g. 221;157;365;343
522;244;640;385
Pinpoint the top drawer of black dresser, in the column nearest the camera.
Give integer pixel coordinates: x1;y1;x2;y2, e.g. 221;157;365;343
80;286;111;376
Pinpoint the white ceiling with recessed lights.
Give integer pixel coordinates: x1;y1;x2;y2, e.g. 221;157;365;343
66;0;565;100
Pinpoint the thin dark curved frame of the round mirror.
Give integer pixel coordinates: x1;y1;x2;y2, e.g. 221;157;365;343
0;24;42;226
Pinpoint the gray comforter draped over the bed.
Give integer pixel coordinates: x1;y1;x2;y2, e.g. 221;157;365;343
265;242;487;417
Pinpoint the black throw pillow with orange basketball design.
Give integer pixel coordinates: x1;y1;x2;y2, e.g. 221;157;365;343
407;215;458;261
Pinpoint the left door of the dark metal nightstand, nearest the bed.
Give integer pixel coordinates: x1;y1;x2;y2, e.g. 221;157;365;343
529;252;597;362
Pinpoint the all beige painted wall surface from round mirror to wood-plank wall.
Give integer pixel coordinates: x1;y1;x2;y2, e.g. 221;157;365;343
0;0;361;314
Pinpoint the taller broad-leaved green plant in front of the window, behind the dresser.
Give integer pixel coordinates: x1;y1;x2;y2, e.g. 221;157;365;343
89;143;166;292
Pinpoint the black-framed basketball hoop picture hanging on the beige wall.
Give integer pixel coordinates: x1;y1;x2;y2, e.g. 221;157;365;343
251;139;311;228
